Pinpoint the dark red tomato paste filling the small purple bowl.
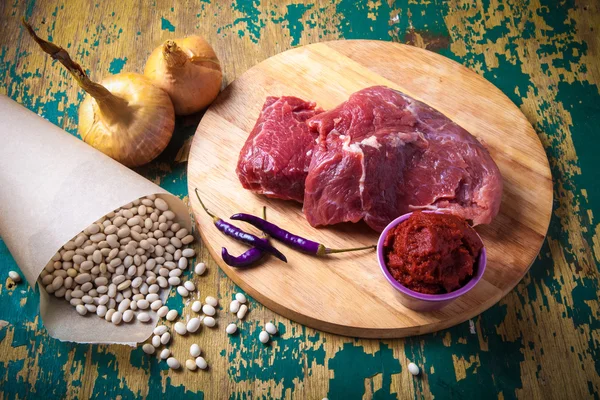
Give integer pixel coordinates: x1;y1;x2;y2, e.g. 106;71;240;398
384;211;483;294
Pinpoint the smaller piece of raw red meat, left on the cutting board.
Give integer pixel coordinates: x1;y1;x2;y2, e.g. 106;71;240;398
236;96;323;202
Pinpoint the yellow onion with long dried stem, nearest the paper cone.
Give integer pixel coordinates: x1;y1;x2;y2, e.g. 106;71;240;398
23;20;175;167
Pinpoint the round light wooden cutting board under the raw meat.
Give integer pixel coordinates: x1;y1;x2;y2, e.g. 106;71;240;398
188;40;552;338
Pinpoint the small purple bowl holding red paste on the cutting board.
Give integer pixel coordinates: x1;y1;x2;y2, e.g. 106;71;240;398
377;211;487;311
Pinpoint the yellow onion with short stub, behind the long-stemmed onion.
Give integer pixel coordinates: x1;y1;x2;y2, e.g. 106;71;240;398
144;36;223;115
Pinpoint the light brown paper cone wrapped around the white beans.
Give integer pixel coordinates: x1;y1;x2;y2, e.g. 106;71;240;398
0;95;191;345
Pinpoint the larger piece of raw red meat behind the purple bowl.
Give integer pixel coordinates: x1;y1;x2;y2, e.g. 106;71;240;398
303;86;502;231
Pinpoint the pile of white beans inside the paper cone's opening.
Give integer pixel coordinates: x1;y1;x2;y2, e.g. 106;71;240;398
40;195;196;325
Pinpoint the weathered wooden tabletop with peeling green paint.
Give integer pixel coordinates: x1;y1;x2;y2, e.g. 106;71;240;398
0;0;600;399
